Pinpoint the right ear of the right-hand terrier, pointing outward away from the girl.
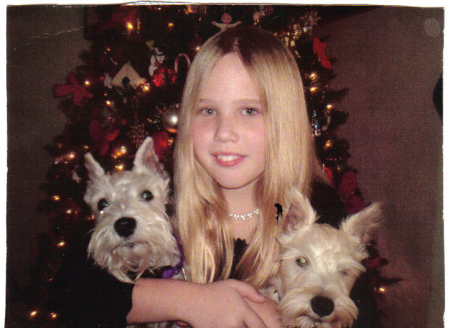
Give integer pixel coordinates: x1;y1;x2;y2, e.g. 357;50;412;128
341;202;382;244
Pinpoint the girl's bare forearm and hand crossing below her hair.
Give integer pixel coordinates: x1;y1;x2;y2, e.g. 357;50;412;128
127;279;268;328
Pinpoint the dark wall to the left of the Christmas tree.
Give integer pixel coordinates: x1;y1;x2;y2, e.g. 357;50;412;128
7;6;89;287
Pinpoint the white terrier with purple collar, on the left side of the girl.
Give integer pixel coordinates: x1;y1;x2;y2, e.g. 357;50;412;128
84;137;180;283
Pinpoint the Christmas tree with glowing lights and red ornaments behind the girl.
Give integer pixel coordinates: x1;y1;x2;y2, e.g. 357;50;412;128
24;5;395;327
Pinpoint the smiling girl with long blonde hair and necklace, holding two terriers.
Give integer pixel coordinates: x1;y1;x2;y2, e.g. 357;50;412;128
128;27;325;327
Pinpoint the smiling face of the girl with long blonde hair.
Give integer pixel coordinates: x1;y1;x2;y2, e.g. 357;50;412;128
192;54;266;192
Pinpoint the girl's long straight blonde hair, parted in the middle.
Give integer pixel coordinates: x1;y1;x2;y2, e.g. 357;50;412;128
174;27;321;288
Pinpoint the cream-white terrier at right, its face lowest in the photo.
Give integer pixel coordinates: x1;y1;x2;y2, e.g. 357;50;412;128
272;192;381;328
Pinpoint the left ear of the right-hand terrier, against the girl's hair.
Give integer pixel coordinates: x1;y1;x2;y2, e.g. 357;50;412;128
283;189;317;231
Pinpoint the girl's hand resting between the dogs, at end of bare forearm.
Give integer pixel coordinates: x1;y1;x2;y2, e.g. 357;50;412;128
183;279;268;328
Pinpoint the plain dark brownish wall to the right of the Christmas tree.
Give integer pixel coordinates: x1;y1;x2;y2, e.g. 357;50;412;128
320;7;445;327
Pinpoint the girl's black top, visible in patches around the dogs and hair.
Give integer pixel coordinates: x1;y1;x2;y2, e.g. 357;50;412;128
49;184;381;328
